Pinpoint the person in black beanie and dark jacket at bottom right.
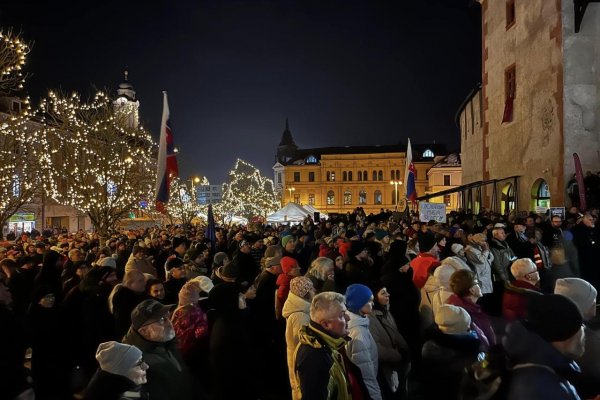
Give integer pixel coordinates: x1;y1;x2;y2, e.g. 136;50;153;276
502;294;585;400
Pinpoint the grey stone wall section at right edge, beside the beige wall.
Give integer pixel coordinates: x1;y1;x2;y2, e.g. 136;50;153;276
562;0;600;191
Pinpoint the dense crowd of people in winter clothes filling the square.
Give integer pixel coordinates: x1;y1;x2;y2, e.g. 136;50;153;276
0;208;600;400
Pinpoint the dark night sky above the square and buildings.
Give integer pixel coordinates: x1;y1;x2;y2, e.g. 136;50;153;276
0;0;481;183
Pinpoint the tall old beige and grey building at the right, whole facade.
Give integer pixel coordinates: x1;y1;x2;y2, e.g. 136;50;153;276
457;0;600;212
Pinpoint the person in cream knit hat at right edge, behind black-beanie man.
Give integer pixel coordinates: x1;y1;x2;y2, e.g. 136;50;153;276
554;278;600;399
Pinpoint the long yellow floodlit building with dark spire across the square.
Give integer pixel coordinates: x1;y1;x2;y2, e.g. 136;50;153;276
273;121;445;214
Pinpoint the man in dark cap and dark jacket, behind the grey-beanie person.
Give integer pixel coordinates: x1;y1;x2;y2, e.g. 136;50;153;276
123;300;193;400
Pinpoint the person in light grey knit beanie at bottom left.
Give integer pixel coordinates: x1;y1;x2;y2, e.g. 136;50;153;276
84;341;148;400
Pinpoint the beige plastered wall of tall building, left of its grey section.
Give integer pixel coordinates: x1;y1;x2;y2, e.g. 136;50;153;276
476;0;565;210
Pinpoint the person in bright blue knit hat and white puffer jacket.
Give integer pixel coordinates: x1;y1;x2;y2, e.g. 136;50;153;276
345;283;382;400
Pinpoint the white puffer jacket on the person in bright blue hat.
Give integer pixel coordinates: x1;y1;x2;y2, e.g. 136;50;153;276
346;311;381;400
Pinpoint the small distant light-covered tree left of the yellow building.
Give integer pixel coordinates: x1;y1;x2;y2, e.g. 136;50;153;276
216;158;278;219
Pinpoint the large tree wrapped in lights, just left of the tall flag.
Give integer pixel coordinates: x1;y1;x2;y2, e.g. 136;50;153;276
38;92;156;239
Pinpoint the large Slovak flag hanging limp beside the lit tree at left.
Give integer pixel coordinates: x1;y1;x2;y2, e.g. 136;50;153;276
155;92;179;212
